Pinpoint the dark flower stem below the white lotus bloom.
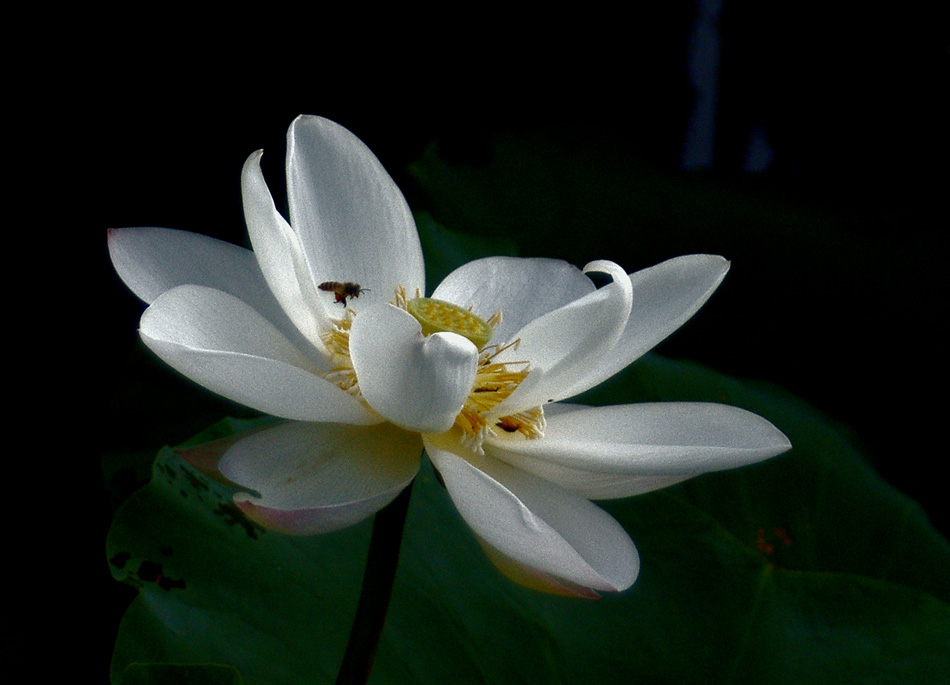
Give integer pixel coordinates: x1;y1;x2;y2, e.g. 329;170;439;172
336;483;412;685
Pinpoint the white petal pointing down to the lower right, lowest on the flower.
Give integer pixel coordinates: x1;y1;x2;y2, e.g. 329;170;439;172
426;436;640;592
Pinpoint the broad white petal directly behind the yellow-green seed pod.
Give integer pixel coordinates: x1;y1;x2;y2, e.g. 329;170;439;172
432;257;595;343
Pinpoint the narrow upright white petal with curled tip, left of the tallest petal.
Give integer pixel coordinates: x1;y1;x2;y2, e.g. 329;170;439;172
241;152;331;350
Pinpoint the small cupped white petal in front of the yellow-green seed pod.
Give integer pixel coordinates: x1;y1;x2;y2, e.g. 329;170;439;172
350;304;478;433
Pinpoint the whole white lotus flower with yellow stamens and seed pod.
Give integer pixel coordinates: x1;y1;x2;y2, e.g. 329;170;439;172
109;116;790;596
